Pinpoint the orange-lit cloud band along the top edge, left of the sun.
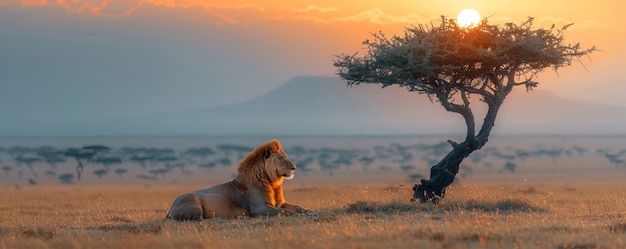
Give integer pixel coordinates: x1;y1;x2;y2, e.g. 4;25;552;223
0;0;432;25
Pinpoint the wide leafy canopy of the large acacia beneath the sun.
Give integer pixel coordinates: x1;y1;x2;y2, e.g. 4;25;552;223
335;17;595;99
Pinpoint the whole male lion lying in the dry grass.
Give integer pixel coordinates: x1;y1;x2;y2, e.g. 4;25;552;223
165;139;316;220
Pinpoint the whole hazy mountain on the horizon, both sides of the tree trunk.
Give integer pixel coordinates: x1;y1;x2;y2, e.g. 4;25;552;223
8;77;626;135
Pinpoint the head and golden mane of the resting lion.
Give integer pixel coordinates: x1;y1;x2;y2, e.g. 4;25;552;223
237;139;296;186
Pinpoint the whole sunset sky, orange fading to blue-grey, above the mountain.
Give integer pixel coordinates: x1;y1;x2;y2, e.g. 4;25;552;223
0;0;626;131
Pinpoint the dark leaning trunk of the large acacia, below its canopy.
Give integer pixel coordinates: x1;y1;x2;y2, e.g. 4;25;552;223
411;99;508;204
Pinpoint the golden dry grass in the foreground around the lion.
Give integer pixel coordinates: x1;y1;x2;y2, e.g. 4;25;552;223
0;184;626;249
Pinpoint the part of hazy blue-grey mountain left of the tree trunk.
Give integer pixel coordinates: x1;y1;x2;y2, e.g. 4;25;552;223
94;77;463;135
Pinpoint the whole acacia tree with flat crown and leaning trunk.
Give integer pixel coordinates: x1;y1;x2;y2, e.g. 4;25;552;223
334;17;596;203
